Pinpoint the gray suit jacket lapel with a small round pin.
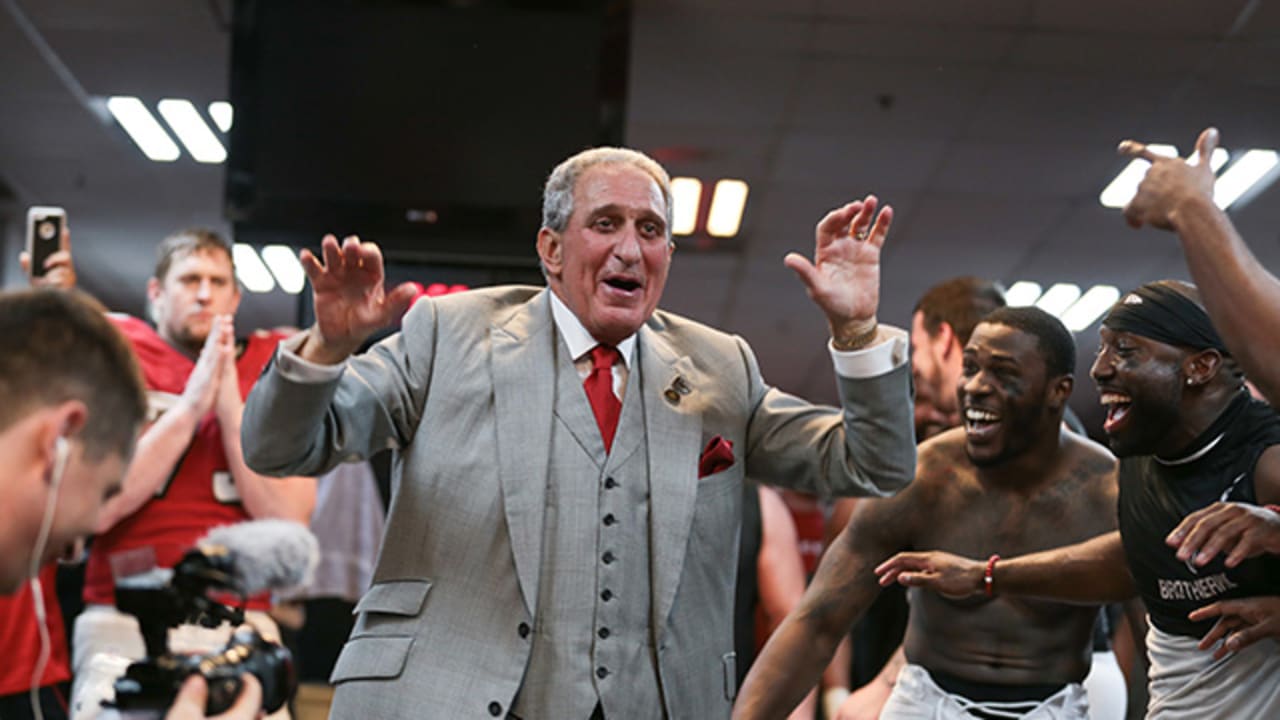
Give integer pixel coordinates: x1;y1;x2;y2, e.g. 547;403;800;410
639;325;701;639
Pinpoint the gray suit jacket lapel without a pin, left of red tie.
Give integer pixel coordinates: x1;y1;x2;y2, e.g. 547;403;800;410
490;291;556;616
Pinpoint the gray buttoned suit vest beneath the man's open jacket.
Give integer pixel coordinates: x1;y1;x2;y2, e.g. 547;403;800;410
512;342;663;720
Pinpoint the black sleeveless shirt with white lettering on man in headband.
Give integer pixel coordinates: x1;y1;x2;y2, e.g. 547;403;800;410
1120;392;1280;638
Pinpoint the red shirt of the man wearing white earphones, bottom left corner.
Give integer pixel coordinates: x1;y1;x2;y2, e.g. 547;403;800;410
0;562;72;696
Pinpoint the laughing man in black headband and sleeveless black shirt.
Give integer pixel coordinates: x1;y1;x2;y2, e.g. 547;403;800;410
877;281;1280;719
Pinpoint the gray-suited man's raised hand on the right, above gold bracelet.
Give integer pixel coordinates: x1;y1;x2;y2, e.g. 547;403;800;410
783;195;893;350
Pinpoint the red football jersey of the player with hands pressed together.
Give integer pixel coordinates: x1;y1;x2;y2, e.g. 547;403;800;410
84;314;285;610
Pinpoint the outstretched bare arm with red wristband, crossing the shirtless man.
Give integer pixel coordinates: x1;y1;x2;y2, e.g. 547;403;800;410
876;532;1137;605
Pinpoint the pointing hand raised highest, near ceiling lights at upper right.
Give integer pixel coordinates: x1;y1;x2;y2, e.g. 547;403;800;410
1116;128;1217;231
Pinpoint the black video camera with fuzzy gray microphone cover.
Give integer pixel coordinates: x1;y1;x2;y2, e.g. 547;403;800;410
113;520;315;717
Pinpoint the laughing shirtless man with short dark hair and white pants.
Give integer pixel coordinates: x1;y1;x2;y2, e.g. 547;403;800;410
735;307;1116;719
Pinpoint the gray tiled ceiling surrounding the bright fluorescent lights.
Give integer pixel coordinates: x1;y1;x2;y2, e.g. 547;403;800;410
0;0;1280;430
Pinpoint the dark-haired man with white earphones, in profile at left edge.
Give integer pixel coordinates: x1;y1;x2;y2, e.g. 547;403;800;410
0;286;261;720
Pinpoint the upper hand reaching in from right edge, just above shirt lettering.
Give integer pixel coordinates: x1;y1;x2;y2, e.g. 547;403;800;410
1165;502;1280;568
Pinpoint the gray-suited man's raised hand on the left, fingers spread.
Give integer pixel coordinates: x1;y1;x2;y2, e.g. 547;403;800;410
300;234;415;364
